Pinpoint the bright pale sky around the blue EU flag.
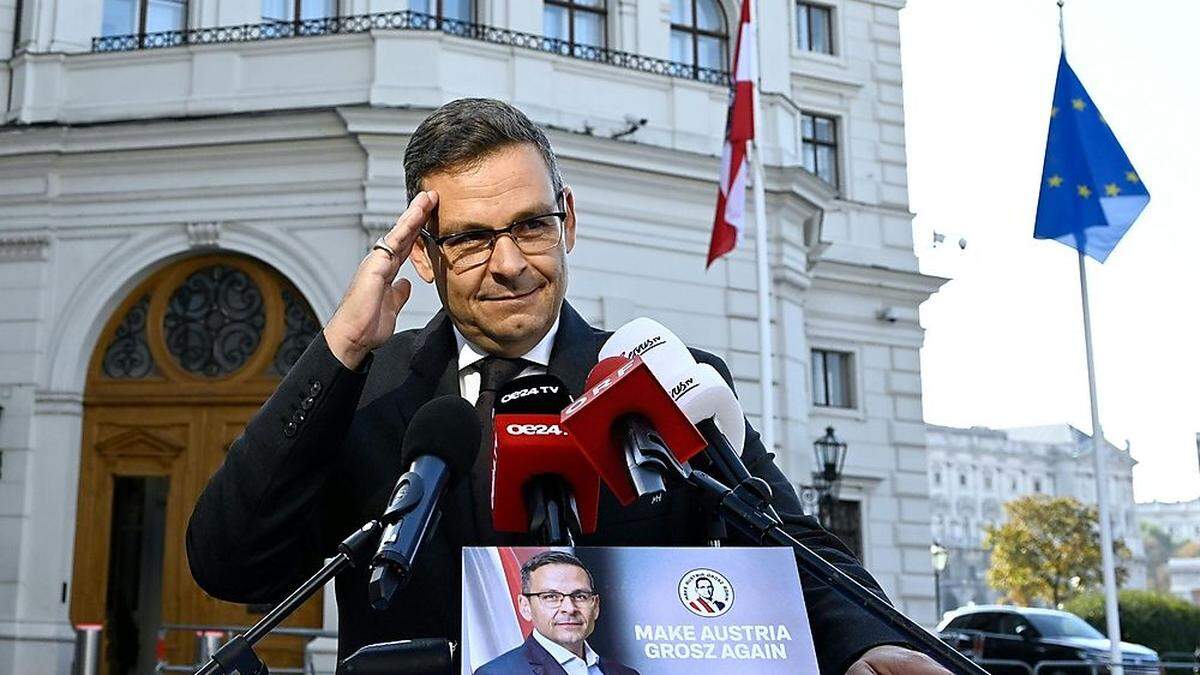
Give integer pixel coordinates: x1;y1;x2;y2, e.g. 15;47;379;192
900;0;1200;502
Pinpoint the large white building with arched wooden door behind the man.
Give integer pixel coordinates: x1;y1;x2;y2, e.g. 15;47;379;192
0;0;942;673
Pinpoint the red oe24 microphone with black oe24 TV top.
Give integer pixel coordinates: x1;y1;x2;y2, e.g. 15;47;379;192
492;374;600;544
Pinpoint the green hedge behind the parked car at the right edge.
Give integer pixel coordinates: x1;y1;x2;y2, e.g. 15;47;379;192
1063;591;1200;653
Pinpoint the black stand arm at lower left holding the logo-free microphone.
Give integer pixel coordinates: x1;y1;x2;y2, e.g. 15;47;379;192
196;520;383;675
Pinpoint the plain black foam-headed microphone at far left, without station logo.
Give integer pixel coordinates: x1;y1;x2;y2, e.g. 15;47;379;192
367;396;481;610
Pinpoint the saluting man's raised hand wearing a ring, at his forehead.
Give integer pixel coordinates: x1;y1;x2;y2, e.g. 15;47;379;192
324;191;438;370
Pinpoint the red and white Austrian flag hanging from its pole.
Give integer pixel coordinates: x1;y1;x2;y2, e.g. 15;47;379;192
706;0;758;267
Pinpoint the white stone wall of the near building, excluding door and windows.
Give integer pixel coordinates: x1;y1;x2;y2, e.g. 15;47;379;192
0;0;942;673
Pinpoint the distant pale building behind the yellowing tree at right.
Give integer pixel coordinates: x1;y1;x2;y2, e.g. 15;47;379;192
928;424;1146;610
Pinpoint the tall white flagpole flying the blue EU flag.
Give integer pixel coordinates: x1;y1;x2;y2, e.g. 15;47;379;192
1058;0;1124;675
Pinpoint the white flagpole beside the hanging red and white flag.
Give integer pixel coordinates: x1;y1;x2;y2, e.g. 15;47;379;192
743;0;775;453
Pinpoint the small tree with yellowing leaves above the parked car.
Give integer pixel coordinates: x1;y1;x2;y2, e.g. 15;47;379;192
984;495;1129;607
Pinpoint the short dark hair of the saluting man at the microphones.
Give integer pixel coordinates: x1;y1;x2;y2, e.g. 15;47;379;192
404;98;563;202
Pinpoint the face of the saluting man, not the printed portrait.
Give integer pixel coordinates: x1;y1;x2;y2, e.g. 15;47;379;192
413;143;575;357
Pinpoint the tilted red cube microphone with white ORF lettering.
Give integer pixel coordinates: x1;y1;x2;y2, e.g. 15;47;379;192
563;356;706;506
